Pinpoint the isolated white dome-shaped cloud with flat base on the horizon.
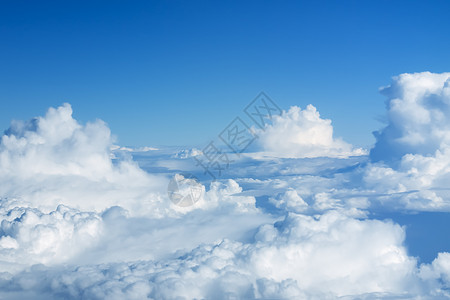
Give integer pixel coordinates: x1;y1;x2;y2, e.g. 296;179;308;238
256;104;365;158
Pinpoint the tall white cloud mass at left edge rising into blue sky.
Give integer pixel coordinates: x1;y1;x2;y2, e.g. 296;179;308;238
0;104;167;215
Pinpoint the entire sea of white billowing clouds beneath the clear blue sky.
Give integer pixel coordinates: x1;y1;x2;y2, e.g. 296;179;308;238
0;72;450;299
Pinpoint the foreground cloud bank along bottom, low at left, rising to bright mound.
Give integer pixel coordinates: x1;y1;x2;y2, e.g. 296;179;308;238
0;212;428;299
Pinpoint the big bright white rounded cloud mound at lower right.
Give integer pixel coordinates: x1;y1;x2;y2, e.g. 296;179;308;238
251;212;415;296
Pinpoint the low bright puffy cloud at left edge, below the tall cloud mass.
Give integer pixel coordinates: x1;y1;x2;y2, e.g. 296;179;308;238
0;205;103;270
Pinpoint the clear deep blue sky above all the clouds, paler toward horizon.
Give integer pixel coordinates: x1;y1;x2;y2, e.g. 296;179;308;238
0;0;450;146
